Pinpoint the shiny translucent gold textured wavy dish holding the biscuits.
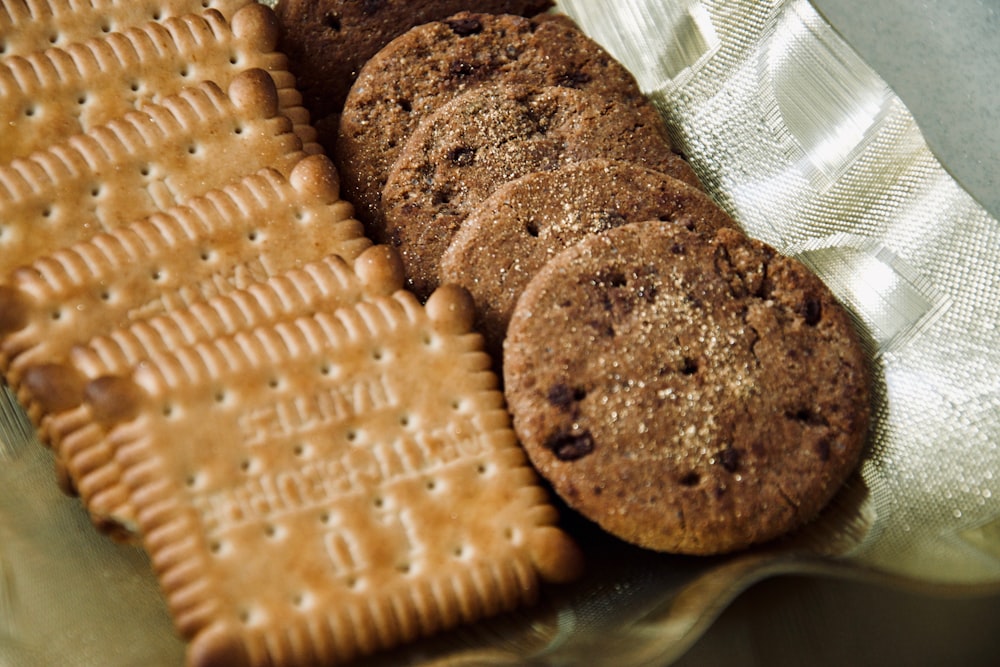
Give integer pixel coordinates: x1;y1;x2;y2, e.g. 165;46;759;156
0;0;1000;667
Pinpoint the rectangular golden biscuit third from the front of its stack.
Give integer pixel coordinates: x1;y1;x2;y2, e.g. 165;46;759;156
0;155;371;424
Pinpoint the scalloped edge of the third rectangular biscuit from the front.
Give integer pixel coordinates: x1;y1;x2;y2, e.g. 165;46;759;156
0;155;368;428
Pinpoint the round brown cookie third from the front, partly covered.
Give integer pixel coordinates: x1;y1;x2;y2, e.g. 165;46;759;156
382;85;697;296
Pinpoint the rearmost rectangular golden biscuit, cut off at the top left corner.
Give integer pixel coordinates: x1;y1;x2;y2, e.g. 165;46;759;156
0;0;252;57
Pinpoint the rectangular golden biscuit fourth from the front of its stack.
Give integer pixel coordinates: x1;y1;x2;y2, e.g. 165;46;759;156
0;69;306;276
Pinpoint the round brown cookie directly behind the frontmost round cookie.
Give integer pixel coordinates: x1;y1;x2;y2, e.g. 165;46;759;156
440;158;736;358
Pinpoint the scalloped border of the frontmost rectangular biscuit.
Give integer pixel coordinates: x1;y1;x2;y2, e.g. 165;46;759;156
72;287;582;667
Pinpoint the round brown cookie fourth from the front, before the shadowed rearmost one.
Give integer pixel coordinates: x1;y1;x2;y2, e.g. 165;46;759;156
334;12;688;224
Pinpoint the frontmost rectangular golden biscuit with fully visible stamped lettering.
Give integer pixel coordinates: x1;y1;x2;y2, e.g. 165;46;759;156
72;287;580;665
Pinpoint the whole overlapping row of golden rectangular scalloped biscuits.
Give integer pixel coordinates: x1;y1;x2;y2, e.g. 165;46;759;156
0;0;580;666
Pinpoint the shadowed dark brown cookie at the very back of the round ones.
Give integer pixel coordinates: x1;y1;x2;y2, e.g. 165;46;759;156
275;0;552;144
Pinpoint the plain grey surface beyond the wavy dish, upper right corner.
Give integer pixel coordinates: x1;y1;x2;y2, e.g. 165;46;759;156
811;0;1000;218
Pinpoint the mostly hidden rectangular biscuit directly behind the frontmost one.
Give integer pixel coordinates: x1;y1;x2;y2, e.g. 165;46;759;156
48;246;404;537
